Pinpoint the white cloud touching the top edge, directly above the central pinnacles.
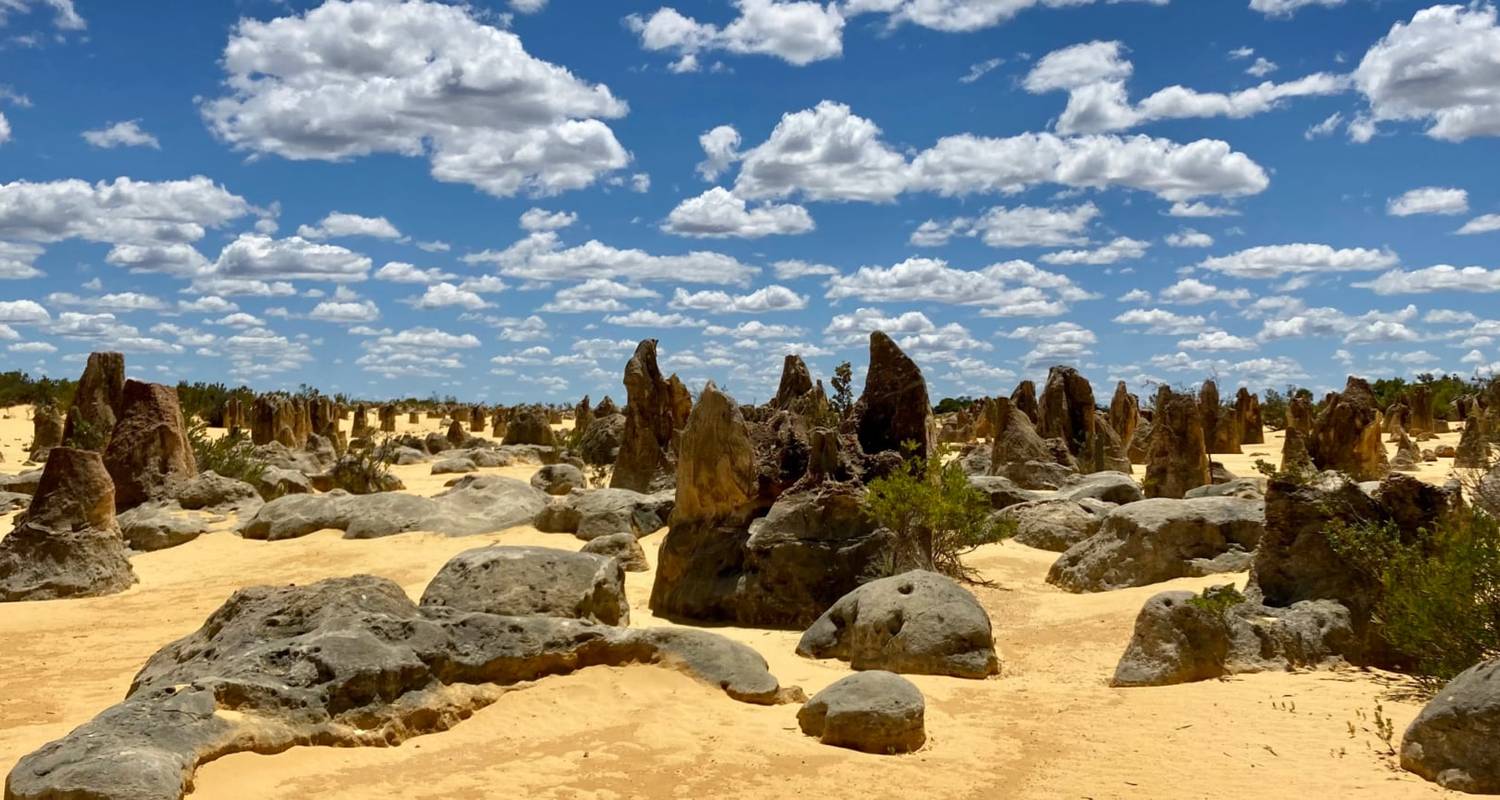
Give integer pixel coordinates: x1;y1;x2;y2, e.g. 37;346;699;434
626;0;845;72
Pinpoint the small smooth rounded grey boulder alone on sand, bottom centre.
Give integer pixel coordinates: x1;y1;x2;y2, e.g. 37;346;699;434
797;671;927;755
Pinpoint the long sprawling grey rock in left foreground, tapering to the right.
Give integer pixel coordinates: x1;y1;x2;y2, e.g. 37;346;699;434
6;575;801;800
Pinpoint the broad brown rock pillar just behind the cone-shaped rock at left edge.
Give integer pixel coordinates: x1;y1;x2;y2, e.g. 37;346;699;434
104;381;198;510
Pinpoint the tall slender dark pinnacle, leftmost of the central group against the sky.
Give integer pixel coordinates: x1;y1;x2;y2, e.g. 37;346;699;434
609;339;692;492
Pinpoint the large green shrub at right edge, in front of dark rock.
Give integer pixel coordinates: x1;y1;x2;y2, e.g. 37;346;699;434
1329;507;1500;684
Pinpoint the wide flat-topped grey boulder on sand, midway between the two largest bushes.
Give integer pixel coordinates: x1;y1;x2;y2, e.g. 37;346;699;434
1047;497;1265;591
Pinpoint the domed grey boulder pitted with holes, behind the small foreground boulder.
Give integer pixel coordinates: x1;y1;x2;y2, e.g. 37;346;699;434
797;570;1001;678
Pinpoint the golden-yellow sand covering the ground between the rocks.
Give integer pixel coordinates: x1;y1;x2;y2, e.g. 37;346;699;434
0;410;1457;800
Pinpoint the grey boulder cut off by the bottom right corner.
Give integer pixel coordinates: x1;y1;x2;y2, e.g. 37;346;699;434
1401;660;1500;794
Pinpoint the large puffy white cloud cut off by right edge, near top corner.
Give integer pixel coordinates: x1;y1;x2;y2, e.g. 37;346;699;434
1355;3;1500;141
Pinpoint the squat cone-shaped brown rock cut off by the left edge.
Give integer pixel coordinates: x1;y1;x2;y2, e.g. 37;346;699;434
0;447;135;602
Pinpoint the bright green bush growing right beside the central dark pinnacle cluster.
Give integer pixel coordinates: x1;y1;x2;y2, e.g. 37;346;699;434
864;446;1016;584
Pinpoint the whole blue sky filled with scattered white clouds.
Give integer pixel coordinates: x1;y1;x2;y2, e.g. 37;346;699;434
0;0;1500;402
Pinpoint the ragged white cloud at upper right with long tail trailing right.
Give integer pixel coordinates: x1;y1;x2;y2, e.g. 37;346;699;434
1022;42;1349;134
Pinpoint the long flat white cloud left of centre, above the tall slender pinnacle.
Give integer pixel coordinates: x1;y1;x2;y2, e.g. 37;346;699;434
464;231;758;285
